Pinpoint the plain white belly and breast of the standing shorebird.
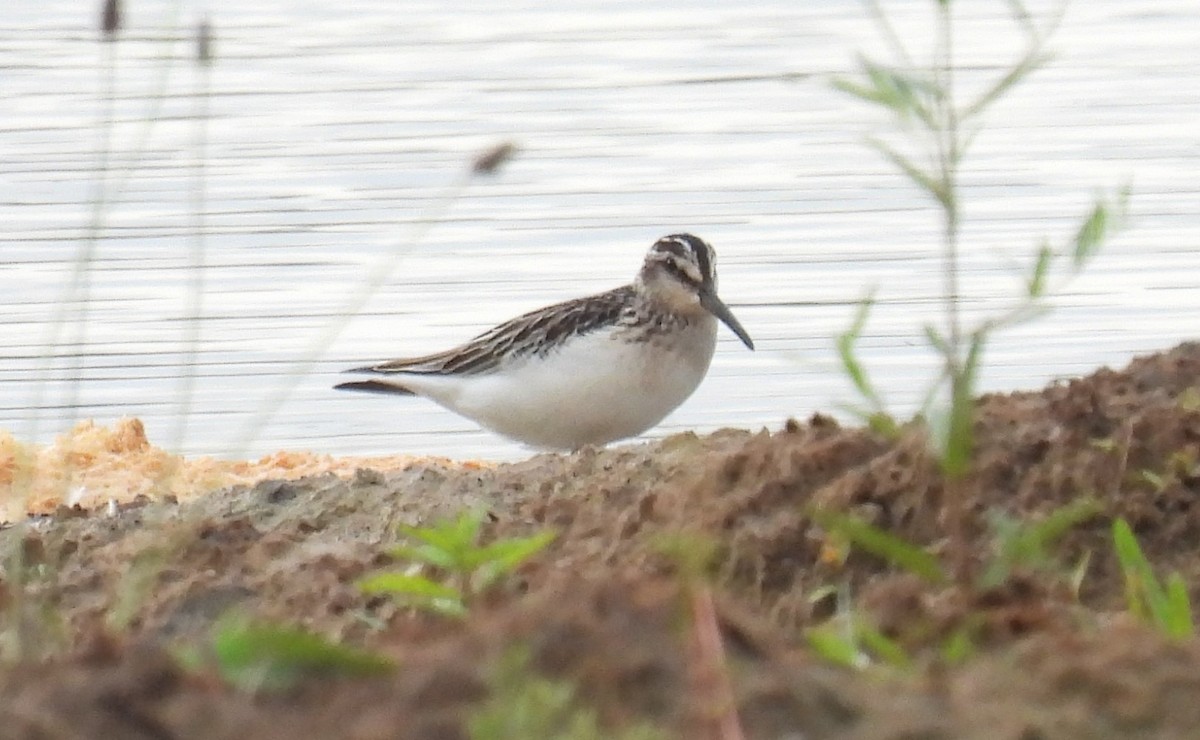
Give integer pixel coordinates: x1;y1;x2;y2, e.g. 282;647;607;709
422;321;716;450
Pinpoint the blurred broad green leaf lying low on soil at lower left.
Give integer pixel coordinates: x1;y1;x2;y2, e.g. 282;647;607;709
212;618;395;691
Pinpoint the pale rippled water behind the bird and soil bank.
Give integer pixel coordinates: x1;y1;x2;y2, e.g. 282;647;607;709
0;0;1200;459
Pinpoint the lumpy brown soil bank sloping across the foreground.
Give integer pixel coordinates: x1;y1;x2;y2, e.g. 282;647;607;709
0;344;1200;740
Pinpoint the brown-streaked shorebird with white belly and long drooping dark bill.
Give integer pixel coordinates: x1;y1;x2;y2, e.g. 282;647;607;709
334;234;754;451
